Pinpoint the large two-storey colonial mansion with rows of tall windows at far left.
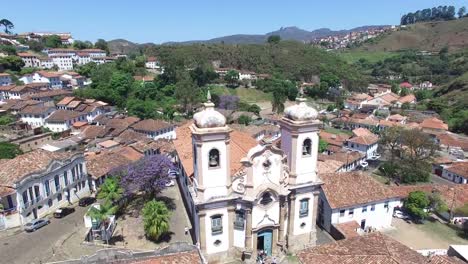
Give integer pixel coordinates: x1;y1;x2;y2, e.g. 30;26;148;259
0;149;89;229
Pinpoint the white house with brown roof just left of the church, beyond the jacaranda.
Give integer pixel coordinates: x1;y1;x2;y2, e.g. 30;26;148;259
130;119;176;140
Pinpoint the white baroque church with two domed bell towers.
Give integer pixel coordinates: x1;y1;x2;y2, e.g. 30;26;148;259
174;91;322;262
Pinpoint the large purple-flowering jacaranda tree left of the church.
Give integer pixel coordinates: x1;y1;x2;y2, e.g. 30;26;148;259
121;155;174;197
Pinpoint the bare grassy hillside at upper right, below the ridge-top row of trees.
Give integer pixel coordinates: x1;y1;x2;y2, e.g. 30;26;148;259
357;17;468;52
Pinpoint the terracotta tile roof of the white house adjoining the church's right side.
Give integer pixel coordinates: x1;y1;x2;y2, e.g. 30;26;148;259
319;172;398;209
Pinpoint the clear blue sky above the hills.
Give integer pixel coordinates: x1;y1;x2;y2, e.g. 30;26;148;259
4;0;468;43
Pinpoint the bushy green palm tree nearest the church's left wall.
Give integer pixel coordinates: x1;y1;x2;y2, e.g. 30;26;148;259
143;200;171;240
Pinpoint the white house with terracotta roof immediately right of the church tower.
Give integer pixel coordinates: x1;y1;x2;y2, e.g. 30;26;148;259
318;172;400;238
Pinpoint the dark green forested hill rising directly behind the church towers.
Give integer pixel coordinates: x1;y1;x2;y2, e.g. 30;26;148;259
144;41;367;89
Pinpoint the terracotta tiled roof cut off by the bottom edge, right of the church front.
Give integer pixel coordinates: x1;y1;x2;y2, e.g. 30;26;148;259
297;233;427;264
